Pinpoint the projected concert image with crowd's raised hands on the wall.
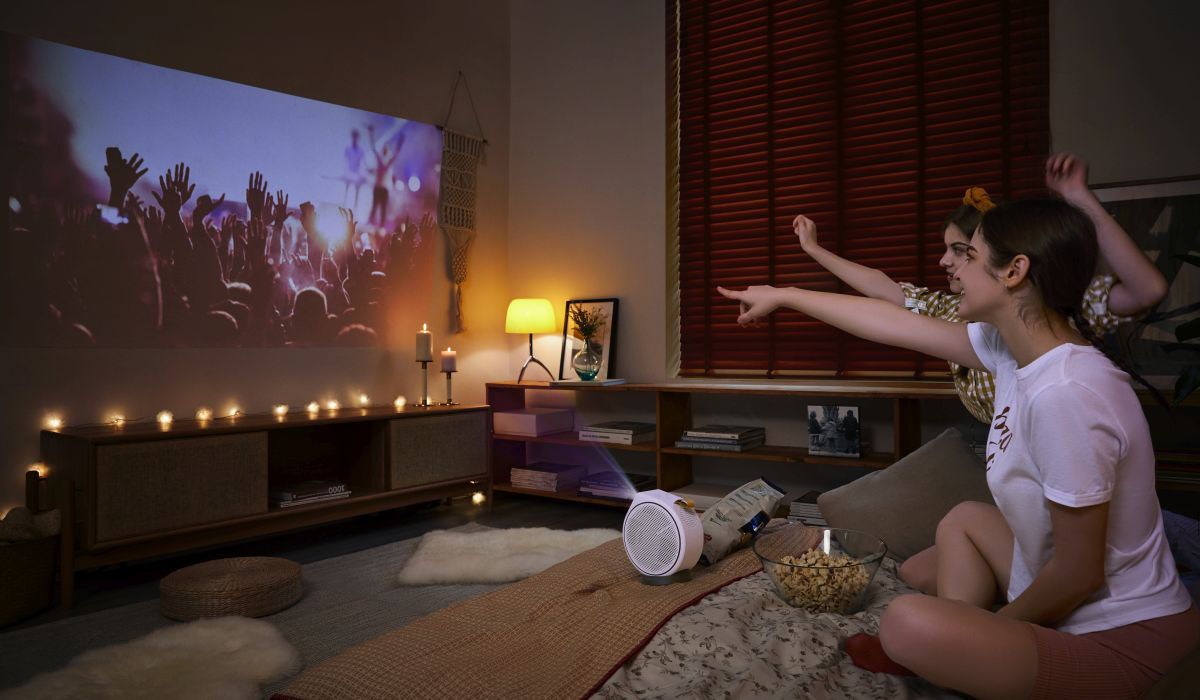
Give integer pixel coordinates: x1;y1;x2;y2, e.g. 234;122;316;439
0;34;442;347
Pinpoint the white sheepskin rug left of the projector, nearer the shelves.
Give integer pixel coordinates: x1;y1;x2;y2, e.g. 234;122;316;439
398;527;620;586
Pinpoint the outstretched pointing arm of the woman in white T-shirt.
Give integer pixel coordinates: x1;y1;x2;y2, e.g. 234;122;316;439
716;286;984;370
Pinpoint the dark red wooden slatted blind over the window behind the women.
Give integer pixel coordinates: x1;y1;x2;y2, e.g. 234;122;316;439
667;0;1049;376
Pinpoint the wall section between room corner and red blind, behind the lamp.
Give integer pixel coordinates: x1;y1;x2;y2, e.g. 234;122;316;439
509;0;666;382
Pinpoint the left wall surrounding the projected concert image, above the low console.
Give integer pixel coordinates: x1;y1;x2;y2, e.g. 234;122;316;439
0;0;509;513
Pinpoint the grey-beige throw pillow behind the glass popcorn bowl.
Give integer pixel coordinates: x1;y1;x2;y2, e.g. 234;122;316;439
817;427;995;561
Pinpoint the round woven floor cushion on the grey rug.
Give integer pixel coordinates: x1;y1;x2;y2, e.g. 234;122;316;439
158;557;304;621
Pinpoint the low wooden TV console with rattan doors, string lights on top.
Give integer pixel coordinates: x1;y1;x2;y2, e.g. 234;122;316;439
37;405;491;606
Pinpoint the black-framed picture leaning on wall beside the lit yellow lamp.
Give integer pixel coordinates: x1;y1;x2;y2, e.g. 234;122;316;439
558;299;617;381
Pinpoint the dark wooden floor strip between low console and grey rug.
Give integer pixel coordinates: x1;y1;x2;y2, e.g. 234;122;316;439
6;493;625;630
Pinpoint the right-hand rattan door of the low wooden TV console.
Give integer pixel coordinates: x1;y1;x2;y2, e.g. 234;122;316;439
388;411;487;489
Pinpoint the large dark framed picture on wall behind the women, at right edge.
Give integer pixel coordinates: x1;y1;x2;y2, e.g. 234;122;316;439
1092;175;1200;390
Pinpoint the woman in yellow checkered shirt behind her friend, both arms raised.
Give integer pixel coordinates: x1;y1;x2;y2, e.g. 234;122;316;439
792;154;1166;424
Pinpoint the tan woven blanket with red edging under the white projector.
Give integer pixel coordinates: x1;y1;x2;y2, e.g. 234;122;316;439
276;531;817;700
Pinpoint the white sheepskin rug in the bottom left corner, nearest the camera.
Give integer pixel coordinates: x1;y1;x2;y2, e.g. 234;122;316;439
0;617;300;700
